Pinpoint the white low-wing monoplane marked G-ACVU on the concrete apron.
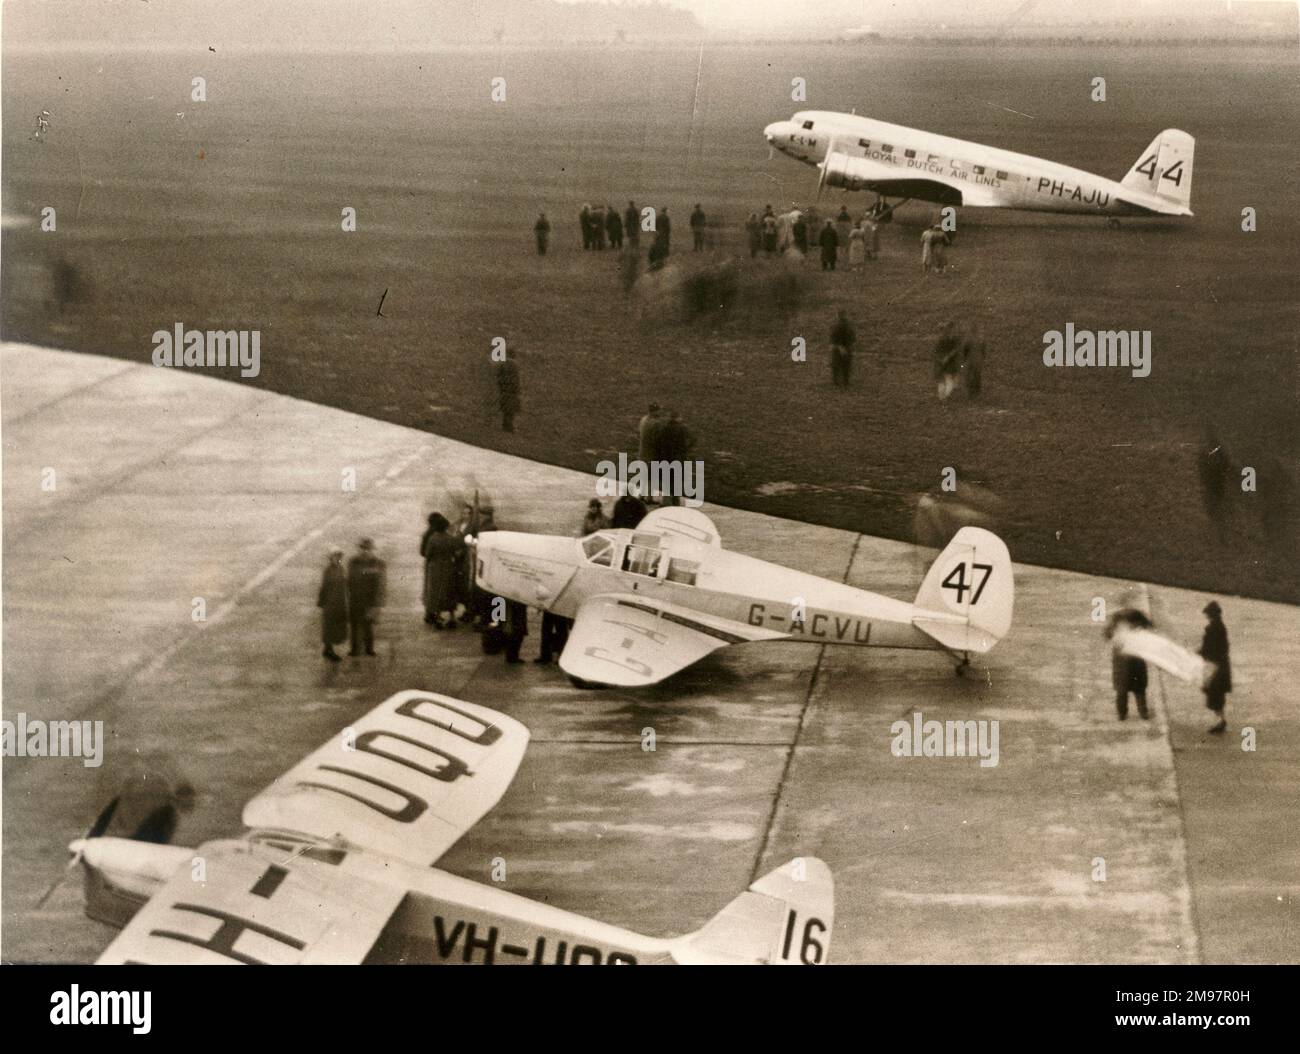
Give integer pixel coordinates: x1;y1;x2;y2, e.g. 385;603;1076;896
475;506;1014;688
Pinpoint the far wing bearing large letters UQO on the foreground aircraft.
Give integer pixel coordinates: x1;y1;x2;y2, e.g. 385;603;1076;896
243;691;528;867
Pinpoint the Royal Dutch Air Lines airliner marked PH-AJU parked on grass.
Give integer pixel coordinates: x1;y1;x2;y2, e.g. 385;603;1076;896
763;110;1196;222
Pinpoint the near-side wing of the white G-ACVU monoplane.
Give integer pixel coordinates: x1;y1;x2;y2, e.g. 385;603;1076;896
560;594;785;688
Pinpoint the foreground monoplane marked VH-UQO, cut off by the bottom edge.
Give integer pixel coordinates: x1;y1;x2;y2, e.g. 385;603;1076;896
69;691;835;966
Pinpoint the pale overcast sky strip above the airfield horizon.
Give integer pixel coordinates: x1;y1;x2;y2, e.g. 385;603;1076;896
0;0;1279;49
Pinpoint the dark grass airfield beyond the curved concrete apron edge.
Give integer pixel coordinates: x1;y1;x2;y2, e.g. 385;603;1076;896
0;43;1300;602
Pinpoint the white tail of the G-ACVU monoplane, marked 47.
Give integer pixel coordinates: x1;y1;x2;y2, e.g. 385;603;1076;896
913;526;1015;652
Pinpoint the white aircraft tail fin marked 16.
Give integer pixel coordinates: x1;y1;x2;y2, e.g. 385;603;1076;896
672;856;835;966
